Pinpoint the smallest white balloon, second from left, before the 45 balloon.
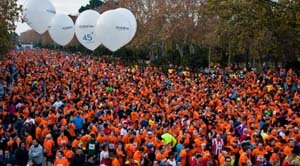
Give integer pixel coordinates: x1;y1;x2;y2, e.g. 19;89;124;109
48;14;75;46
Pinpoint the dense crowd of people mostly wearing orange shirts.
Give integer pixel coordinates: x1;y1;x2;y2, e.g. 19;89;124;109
0;50;300;166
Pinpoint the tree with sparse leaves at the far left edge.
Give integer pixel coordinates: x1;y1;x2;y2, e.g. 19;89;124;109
0;0;21;55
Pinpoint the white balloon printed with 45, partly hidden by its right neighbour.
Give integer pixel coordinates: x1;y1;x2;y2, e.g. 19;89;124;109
75;10;101;51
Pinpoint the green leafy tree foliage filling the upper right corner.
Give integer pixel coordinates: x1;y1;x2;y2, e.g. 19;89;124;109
207;0;300;67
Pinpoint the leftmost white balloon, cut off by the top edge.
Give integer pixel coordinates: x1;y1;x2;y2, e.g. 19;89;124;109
23;0;56;34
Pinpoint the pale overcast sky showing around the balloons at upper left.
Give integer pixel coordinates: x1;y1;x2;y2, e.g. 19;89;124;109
16;0;89;34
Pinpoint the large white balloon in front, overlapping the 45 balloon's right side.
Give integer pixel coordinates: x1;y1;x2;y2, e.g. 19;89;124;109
97;10;132;51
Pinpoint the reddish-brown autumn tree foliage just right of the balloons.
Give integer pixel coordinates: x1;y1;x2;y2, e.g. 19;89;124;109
120;0;209;64
